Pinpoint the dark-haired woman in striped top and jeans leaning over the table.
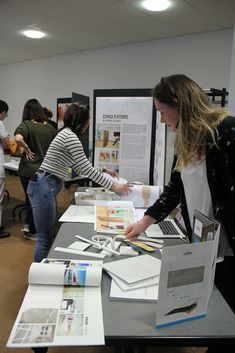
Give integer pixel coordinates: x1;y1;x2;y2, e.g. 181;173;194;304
27;104;130;262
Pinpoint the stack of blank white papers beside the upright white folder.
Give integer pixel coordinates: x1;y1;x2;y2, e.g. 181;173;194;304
103;255;161;301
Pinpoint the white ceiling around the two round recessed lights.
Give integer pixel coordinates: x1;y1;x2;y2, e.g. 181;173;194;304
0;0;235;64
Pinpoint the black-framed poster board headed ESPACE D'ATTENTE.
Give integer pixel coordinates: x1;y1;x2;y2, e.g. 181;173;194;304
93;89;165;185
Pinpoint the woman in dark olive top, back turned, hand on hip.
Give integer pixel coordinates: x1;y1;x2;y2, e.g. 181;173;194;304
14;99;56;239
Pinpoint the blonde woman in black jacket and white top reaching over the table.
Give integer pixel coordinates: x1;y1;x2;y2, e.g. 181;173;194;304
125;75;235;312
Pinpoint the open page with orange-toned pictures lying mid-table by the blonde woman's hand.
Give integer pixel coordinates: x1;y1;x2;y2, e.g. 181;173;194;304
95;205;135;234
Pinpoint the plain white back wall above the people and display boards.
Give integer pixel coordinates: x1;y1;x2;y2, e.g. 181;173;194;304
0;29;233;182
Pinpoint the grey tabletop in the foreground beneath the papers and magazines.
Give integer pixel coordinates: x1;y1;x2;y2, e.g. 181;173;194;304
48;223;235;352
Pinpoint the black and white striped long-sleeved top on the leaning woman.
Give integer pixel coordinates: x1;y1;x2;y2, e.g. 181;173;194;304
40;128;112;189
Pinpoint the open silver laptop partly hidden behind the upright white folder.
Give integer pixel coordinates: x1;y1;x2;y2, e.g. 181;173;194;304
145;218;186;239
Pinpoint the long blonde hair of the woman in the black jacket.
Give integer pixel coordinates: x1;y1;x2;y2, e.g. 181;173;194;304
153;74;228;171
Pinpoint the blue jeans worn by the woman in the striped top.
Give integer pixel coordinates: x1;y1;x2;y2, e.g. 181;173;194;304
27;174;62;262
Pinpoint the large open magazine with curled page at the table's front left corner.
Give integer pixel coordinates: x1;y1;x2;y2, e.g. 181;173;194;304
7;259;104;347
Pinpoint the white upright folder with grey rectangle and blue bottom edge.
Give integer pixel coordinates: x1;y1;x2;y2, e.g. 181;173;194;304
156;226;220;328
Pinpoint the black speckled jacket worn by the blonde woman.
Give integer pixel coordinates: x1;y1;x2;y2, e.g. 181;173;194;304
145;116;235;253
